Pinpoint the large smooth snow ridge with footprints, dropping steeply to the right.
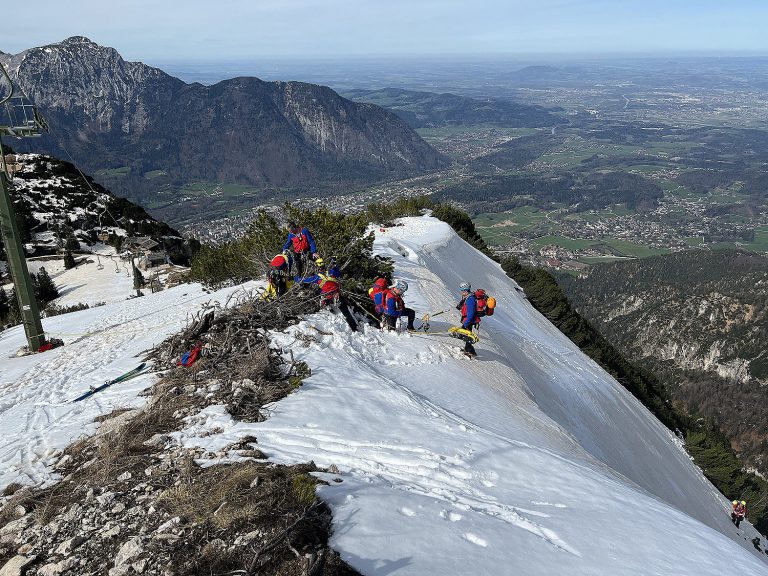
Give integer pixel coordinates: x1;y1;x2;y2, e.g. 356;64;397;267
176;217;768;576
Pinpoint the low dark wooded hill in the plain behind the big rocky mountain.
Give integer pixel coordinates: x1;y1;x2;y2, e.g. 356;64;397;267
344;88;567;128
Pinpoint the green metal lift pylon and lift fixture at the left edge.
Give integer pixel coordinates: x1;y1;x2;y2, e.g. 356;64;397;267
0;64;47;352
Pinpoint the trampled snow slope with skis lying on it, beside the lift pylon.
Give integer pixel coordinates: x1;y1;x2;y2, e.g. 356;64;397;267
0;280;258;492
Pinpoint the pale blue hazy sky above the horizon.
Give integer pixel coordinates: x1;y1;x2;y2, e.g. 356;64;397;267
0;0;768;63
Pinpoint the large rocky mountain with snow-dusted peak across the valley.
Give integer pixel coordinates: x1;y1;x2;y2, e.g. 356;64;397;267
0;36;447;198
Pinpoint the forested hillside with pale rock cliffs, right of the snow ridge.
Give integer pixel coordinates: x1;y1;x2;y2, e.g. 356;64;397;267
564;250;768;472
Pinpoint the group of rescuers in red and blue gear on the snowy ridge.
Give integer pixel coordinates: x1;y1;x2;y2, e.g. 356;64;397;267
264;222;495;356
